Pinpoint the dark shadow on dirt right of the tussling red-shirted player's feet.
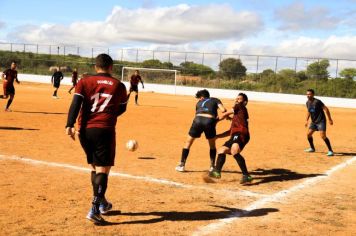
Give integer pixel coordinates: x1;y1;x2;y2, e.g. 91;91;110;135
249;168;324;185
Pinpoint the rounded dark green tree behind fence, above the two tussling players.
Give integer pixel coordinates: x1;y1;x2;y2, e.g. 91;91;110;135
219;58;247;79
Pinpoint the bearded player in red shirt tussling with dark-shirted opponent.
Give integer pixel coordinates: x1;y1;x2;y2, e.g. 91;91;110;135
209;93;252;184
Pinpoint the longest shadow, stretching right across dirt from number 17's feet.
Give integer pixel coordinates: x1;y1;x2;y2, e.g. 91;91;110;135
107;205;279;224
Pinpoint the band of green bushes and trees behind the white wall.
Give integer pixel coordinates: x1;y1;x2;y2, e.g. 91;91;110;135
0;51;356;98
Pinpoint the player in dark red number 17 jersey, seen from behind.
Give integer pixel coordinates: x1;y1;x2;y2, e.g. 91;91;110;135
66;54;127;224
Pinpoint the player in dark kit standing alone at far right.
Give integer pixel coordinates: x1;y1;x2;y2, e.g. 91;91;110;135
305;89;334;156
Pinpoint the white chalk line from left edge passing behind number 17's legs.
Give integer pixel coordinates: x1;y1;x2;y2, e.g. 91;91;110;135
0;154;268;199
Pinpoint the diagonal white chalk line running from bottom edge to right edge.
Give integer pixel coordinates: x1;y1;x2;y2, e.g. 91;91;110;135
192;156;356;236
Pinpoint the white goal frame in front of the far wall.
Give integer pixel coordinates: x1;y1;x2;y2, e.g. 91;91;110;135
121;66;178;94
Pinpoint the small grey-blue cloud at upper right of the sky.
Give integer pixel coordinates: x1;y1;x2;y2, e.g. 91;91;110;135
275;2;341;31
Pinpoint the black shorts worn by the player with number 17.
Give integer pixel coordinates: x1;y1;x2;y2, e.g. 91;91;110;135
79;128;116;166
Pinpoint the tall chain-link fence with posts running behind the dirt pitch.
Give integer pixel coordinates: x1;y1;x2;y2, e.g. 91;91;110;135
0;43;356;98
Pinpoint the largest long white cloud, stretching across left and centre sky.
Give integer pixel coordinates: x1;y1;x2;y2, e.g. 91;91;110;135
9;5;263;46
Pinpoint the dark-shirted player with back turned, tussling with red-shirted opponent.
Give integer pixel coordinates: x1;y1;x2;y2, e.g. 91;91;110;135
176;89;226;172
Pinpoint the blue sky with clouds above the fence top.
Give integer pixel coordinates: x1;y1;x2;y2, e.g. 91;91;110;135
0;0;356;60
